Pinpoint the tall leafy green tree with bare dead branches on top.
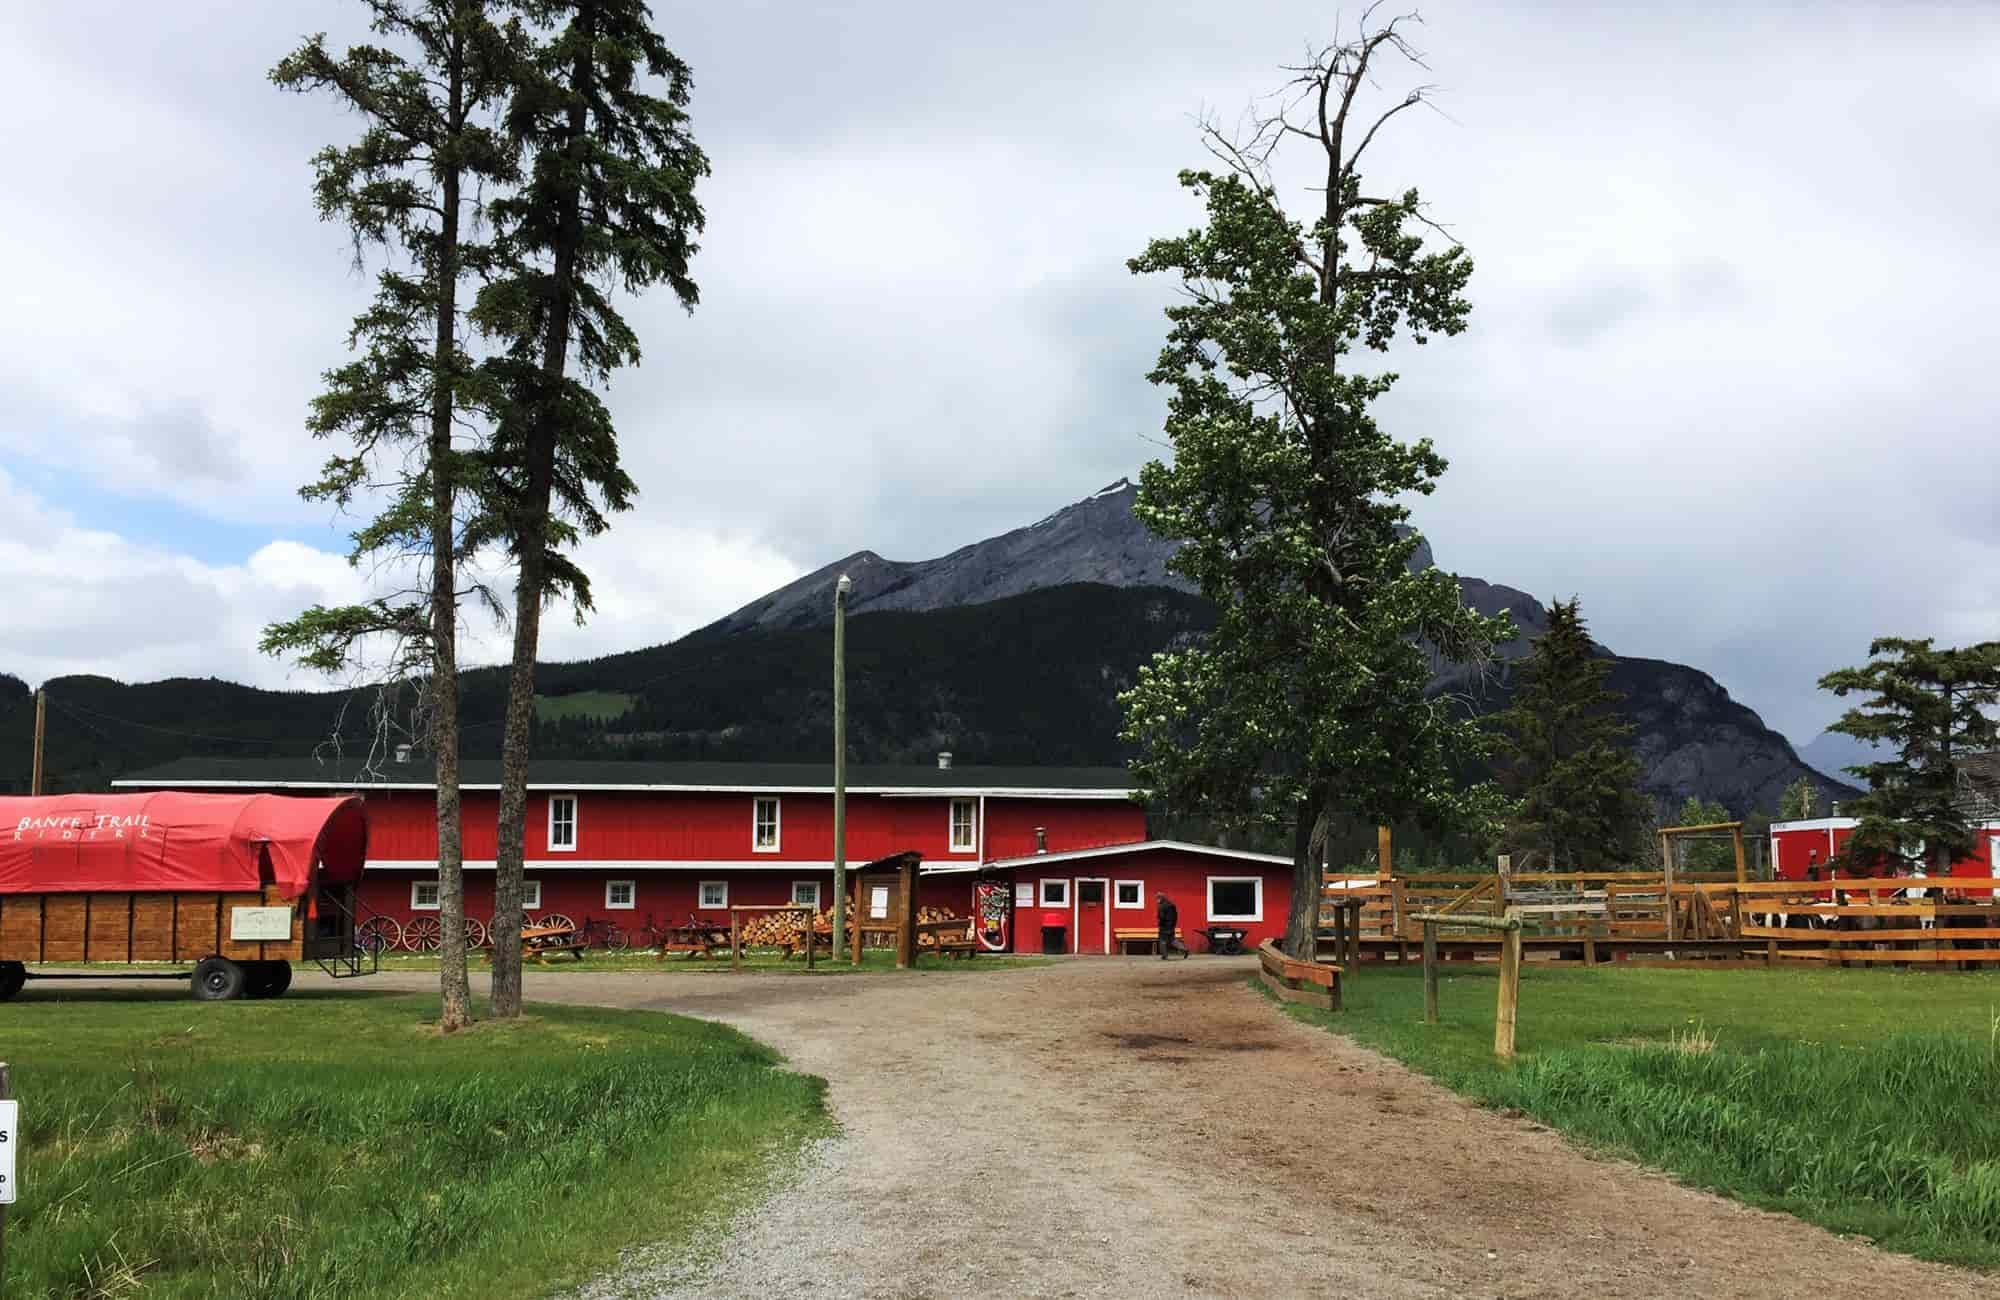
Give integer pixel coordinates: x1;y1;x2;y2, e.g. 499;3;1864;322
1124;20;1512;954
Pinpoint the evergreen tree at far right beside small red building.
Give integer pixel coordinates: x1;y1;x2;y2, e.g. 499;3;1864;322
1820;636;2000;876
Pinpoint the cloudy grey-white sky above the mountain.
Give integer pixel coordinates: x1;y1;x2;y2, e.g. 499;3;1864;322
0;0;2000;742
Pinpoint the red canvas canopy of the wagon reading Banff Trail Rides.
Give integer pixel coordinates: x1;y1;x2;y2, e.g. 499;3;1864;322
0;792;368;898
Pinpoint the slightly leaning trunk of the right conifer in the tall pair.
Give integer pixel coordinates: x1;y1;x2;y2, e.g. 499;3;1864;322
492;10;596;1018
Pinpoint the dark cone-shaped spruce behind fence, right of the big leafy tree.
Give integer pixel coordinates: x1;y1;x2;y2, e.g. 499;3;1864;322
1494;598;1646;870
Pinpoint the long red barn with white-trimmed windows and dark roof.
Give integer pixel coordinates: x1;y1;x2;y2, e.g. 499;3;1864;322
116;758;1290;952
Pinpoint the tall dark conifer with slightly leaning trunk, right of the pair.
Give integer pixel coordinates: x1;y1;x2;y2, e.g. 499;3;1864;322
474;0;708;1016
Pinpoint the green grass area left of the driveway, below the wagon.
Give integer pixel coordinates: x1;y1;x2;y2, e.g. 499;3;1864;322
0;988;828;1300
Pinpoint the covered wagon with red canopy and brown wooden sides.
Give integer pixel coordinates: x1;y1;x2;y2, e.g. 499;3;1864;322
0;792;368;1000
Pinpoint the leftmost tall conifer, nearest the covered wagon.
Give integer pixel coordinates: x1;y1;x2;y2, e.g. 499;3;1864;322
264;0;522;1032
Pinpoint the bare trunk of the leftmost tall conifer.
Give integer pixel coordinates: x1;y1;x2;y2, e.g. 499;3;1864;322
430;38;472;1034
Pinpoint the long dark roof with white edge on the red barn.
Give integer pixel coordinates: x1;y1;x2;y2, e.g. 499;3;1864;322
112;758;1134;798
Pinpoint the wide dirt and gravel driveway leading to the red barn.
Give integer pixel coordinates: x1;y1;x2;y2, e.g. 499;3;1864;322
344;958;2000;1300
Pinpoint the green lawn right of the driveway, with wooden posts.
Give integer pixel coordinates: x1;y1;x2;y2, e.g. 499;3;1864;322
1286;964;2000;1270
